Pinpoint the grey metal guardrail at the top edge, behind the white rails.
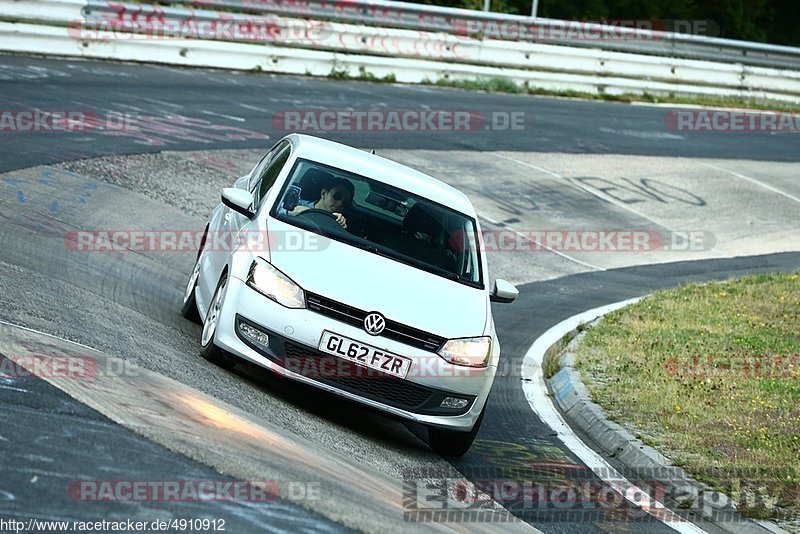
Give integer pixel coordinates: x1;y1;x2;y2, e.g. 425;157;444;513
158;0;800;69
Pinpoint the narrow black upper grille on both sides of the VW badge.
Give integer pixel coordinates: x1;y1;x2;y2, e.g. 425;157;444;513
306;293;446;352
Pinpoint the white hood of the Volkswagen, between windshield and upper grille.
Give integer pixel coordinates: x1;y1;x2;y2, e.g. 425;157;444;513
270;220;489;339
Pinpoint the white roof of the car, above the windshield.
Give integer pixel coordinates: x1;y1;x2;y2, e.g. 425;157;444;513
287;134;476;217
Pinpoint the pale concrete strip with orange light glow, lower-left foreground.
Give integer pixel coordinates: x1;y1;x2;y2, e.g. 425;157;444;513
0;321;536;532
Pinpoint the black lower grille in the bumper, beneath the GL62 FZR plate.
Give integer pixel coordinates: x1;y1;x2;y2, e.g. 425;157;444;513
283;341;437;410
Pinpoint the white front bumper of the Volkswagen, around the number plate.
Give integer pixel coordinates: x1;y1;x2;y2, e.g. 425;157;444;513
214;277;496;431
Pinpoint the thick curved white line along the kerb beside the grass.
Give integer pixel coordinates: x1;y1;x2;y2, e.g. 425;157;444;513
522;298;705;534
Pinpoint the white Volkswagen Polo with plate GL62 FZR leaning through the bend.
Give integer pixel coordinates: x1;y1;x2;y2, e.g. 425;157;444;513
182;134;517;456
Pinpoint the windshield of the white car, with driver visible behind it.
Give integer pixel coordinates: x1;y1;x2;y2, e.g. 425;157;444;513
271;159;483;288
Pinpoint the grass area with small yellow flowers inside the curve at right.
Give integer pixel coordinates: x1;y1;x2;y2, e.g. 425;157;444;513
576;273;800;518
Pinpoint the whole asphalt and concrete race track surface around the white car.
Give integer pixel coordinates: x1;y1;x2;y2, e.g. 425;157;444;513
0;56;800;533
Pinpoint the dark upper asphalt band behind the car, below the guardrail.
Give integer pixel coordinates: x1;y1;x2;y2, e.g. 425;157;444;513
0;56;800;171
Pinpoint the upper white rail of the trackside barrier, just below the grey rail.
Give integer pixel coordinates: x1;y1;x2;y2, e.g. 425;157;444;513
67;0;800;95
